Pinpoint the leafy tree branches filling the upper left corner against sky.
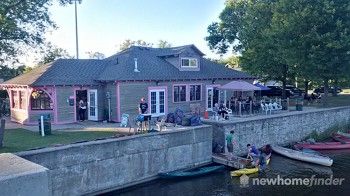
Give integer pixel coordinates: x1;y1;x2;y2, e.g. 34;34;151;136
0;0;70;62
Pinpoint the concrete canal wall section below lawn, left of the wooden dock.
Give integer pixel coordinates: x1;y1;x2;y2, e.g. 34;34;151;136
17;125;212;195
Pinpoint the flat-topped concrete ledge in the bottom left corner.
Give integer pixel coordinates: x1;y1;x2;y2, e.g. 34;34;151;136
0;153;51;196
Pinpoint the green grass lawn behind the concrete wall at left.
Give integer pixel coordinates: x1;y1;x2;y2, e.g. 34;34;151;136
0;129;117;153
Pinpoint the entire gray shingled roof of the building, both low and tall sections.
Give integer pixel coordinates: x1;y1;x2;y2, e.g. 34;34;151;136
4;45;254;86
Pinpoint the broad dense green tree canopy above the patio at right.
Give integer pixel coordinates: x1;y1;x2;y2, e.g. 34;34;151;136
206;0;350;99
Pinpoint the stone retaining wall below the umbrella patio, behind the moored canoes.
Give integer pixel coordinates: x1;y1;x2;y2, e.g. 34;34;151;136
204;107;350;155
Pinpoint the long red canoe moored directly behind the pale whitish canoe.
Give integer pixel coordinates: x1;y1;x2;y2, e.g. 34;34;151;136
294;141;350;150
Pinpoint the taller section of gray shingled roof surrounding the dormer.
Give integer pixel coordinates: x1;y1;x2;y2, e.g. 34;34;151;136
99;45;254;81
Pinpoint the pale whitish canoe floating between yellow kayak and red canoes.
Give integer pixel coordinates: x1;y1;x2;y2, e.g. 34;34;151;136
272;146;333;166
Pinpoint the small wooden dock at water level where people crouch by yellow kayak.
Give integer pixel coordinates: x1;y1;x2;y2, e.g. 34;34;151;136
212;154;250;169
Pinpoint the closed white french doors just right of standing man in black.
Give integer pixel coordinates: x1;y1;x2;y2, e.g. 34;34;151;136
149;89;167;116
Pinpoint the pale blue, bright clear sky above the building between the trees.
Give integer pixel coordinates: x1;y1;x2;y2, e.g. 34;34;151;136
26;0;225;61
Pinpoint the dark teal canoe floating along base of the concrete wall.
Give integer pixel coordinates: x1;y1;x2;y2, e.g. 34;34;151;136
159;165;225;179
